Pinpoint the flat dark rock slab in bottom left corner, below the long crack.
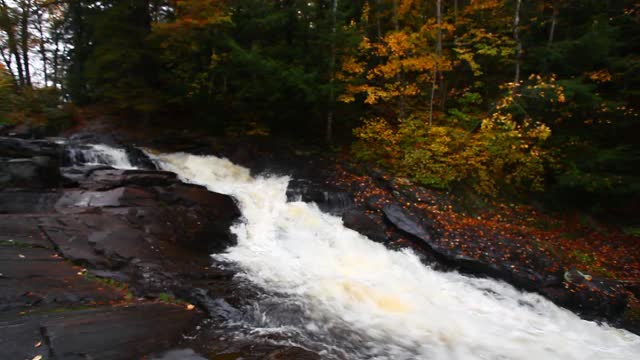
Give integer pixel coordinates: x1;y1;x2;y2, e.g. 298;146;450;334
0;303;202;360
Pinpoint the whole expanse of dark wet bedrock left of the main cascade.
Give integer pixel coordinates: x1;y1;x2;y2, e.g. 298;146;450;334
0;135;318;359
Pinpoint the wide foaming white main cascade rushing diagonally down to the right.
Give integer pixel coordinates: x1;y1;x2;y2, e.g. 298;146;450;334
144;154;640;360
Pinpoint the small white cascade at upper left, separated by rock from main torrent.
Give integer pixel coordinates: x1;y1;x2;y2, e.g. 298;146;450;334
67;144;135;169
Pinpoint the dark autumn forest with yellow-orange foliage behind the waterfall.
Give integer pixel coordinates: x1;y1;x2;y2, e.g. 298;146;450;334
0;0;640;225
